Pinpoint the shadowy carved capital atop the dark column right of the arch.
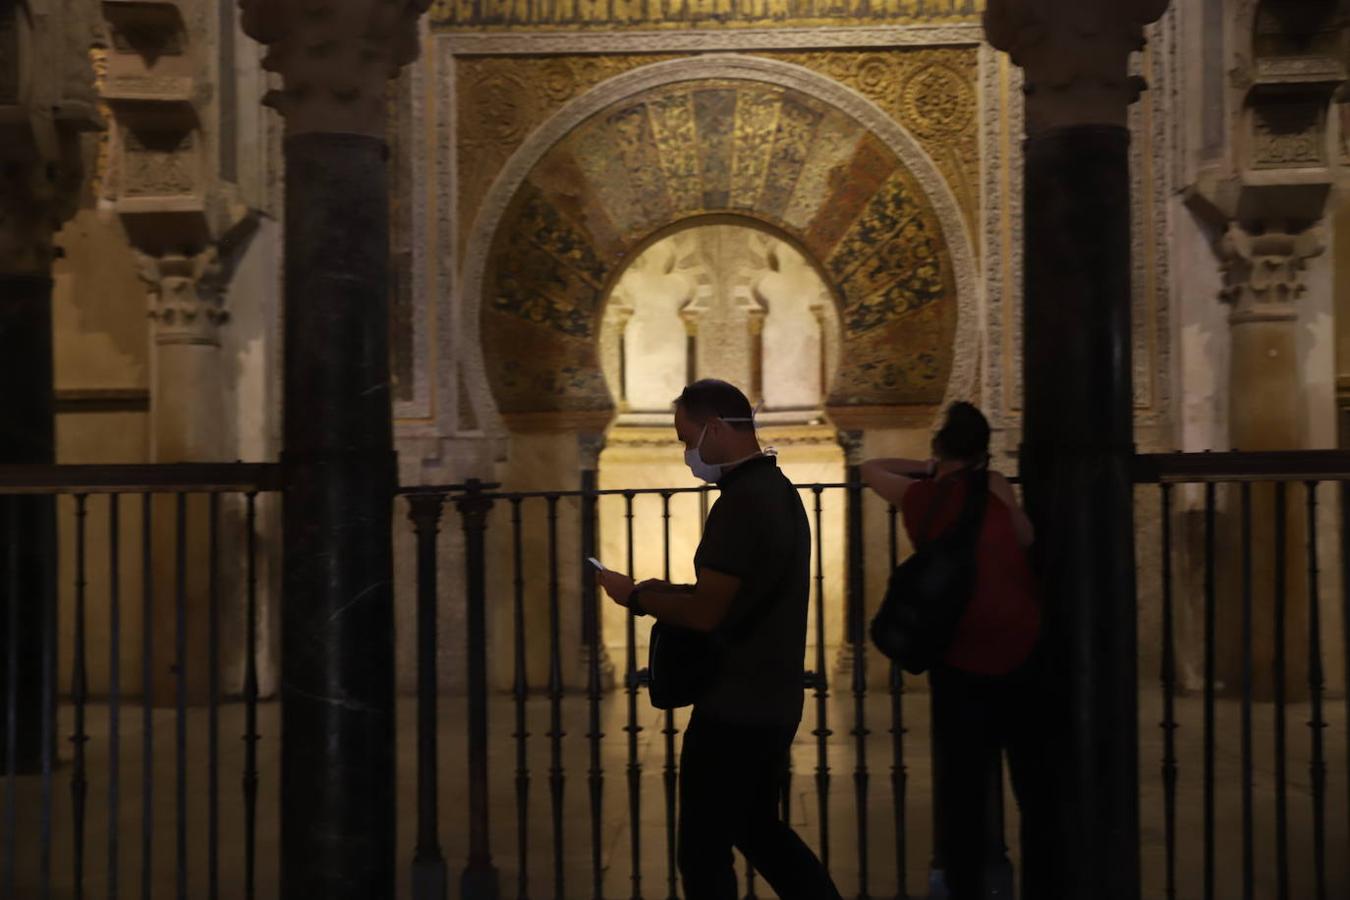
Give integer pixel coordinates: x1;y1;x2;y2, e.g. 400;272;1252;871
984;0;1168;135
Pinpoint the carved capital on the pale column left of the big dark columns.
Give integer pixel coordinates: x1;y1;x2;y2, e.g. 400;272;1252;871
138;247;230;347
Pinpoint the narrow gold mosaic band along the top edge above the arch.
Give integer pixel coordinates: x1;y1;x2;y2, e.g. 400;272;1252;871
429;0;984;31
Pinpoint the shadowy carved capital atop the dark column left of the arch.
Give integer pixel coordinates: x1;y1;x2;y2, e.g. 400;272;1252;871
239;0;432;138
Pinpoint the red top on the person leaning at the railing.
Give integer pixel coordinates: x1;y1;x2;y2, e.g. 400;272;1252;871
900;479;1041;675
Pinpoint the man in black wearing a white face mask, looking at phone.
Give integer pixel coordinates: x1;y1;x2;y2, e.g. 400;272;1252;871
599;379;840;900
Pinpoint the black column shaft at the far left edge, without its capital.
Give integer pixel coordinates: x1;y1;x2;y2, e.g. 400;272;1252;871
0;275;57;772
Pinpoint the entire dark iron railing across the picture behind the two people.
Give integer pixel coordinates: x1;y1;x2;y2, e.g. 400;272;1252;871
0;452;1350;900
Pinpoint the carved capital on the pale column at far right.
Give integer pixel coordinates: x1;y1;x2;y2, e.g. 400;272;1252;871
1218;224;1326;325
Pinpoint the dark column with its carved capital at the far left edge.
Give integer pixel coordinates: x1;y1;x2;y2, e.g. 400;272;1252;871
0;3;101;772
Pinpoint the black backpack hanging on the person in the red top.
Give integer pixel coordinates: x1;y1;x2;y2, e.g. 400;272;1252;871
871;466;990;675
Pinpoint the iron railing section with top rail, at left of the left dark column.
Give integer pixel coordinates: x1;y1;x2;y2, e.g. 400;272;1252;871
0;464;279;900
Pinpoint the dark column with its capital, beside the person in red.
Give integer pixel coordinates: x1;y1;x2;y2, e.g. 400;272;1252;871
984;0;1166;900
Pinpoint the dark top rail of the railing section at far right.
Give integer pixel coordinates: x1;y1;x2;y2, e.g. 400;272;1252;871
1134;449;1350;484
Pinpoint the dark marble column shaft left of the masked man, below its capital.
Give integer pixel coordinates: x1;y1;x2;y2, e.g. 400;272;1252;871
281;132;397;900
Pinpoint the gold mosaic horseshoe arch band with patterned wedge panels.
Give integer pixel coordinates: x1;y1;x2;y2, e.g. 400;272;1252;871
479;78;957;417
